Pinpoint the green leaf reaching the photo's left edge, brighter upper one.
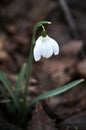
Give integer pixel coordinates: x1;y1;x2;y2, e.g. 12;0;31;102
0;71;19;109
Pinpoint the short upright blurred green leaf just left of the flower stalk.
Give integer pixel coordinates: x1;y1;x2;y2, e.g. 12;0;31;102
15;64;26;99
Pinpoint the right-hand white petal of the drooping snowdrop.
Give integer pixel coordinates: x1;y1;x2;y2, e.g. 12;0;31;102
48;36;59;55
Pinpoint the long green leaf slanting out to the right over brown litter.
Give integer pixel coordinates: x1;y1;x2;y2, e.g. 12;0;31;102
29;79;84;107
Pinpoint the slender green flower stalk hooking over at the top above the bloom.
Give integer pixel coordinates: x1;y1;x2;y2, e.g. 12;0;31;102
23;21;51;107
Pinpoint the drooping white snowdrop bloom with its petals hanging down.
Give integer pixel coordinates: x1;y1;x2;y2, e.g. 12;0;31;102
34;35;59;61
